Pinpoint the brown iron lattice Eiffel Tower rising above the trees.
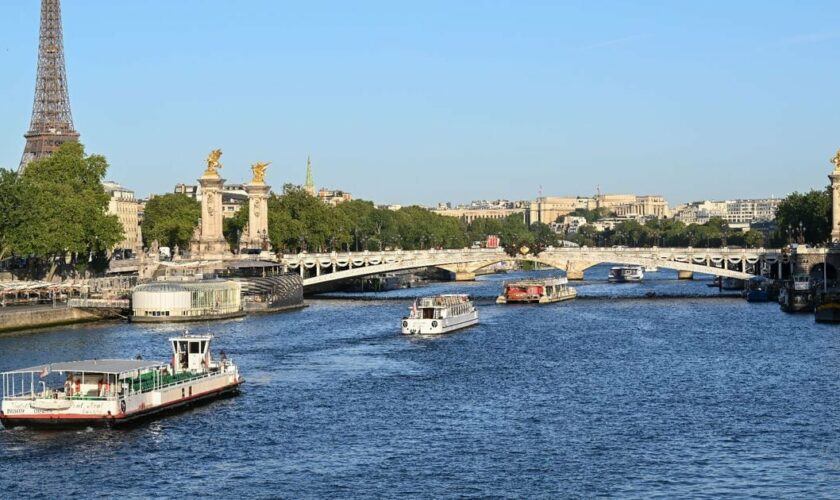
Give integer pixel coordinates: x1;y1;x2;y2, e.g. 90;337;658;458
18;0;79;173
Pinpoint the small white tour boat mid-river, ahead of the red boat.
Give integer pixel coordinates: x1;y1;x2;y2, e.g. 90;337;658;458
402;294;478;335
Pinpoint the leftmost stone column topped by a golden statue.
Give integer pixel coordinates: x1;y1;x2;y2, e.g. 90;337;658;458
190;149;231;259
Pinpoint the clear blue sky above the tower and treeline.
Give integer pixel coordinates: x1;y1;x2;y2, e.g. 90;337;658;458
0;0;840;204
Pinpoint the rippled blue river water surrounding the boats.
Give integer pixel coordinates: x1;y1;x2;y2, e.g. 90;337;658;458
0;267;840;498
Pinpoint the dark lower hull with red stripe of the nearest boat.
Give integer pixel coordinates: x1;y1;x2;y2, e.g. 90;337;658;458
0;378;245;430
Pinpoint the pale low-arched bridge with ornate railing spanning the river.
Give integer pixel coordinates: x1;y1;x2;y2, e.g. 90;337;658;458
279;247;788;288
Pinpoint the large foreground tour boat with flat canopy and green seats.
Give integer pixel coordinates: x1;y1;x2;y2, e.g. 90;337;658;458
0;335;244;429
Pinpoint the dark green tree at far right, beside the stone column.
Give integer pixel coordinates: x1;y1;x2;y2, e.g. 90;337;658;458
773;188;831;246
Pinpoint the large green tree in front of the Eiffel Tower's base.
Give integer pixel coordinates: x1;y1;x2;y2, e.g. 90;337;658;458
5;142;123;279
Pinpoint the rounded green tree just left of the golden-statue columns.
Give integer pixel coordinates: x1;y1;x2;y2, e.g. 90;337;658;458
141;193;201;249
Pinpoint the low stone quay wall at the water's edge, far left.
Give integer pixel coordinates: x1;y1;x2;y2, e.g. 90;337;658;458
0;304;120;333
